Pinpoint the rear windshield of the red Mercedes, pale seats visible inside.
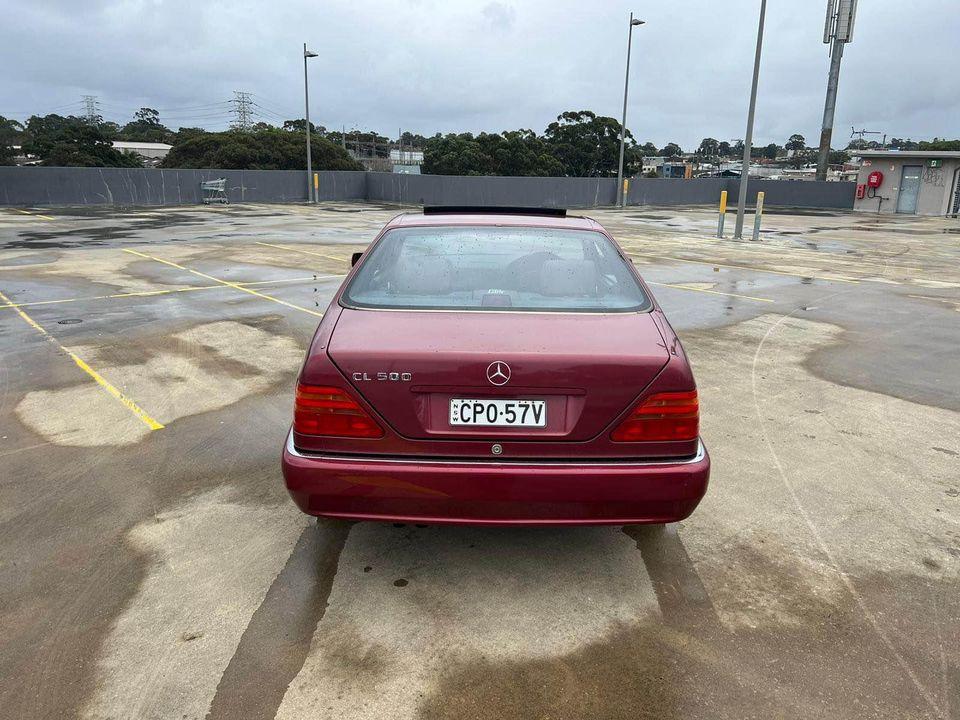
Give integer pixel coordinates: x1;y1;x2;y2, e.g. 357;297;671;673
343;226;650;312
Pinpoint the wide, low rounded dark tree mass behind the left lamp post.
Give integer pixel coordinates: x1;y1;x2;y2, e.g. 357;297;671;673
160;128;363;170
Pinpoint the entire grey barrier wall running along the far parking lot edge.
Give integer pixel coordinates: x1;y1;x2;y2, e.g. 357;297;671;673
0;167;855;209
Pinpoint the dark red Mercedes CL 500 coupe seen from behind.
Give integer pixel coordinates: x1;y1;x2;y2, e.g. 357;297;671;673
282;208;710;525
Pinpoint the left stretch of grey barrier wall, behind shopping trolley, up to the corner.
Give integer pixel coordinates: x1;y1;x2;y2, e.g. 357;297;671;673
0;167;366;206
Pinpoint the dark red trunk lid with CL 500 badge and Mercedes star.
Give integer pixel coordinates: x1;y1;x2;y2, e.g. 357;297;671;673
328;309;668;442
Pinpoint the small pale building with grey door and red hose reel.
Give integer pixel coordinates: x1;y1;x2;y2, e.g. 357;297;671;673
853;150;960;217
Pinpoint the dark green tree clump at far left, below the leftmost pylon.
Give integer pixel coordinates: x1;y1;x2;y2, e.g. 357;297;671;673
23;115;141;167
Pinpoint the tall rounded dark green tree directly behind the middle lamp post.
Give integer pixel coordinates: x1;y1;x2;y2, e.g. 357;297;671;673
544;110;642;177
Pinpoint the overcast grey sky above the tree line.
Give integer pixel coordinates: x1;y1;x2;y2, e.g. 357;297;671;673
0;0;960;149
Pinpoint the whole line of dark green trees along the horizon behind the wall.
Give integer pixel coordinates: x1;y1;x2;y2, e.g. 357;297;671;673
0;108;960;177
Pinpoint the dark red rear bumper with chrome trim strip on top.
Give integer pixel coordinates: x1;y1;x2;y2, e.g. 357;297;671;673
282;434;710;525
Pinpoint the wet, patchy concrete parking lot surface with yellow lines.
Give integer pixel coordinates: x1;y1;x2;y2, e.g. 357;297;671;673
0;203;960;720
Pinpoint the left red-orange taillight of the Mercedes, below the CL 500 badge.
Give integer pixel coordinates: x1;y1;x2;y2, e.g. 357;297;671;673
293;385;383;438
